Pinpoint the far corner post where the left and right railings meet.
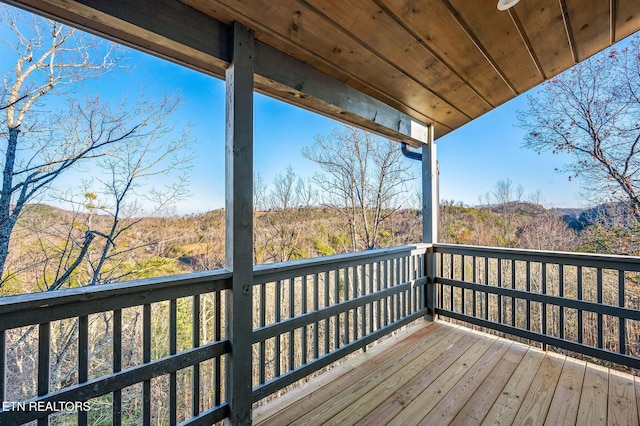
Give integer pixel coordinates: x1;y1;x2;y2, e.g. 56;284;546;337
422;124;439;321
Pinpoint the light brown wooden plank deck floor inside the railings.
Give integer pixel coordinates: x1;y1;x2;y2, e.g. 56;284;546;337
253;320;640;426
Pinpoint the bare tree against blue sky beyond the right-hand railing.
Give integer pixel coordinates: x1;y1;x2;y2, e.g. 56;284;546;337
519;35;640;217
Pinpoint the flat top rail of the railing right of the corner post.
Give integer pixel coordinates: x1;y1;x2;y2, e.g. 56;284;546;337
434;244;640;272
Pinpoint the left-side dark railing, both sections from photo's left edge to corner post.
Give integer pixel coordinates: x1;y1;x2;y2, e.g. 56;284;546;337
0;245;427;425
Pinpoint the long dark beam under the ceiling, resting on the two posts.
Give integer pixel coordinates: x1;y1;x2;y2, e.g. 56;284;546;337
2;0;428;147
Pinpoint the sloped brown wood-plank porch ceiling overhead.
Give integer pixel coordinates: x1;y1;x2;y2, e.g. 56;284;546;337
4;0;640;141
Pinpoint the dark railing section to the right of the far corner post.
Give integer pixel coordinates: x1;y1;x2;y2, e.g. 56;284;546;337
434;244;640;369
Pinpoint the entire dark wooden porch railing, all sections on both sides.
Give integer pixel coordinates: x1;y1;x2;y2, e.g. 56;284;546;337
0;244;640;425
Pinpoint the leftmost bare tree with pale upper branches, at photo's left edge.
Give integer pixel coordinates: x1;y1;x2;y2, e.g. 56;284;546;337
0;8;122;282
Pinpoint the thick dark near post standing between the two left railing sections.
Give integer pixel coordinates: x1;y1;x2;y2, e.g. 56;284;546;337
225;23;255;425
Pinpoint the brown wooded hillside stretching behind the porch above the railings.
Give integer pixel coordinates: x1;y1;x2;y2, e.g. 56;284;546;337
0;202;640;295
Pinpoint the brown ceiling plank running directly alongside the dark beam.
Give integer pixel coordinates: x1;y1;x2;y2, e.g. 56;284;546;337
186;0;470;135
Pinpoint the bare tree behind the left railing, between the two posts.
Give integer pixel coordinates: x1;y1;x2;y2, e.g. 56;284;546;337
302;126;414;251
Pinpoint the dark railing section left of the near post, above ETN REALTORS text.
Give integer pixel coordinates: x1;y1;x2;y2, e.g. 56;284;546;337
0;271;231;425
